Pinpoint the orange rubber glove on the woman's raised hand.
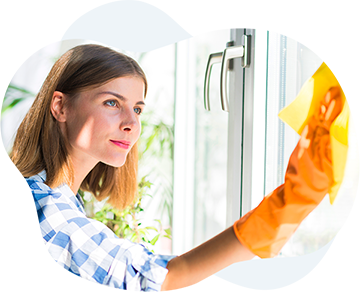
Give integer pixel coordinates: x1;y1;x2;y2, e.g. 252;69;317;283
234;87;342;258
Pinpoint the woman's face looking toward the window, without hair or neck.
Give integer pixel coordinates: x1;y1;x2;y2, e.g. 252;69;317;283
65;77;145;167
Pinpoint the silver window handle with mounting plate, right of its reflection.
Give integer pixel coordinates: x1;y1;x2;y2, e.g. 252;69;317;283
220;35;251;112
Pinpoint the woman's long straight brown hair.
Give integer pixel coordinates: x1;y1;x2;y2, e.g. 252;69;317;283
11;45;147;209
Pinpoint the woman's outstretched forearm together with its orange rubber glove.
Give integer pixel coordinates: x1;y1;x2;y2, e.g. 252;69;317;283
161;87;343;292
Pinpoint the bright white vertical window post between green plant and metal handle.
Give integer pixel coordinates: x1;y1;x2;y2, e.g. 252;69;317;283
172;39;196;254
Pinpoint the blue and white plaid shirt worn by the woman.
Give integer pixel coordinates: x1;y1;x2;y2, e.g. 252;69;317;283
27;171;174;291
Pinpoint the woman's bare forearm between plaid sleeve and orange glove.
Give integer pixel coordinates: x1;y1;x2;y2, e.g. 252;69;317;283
161;227;255;292
